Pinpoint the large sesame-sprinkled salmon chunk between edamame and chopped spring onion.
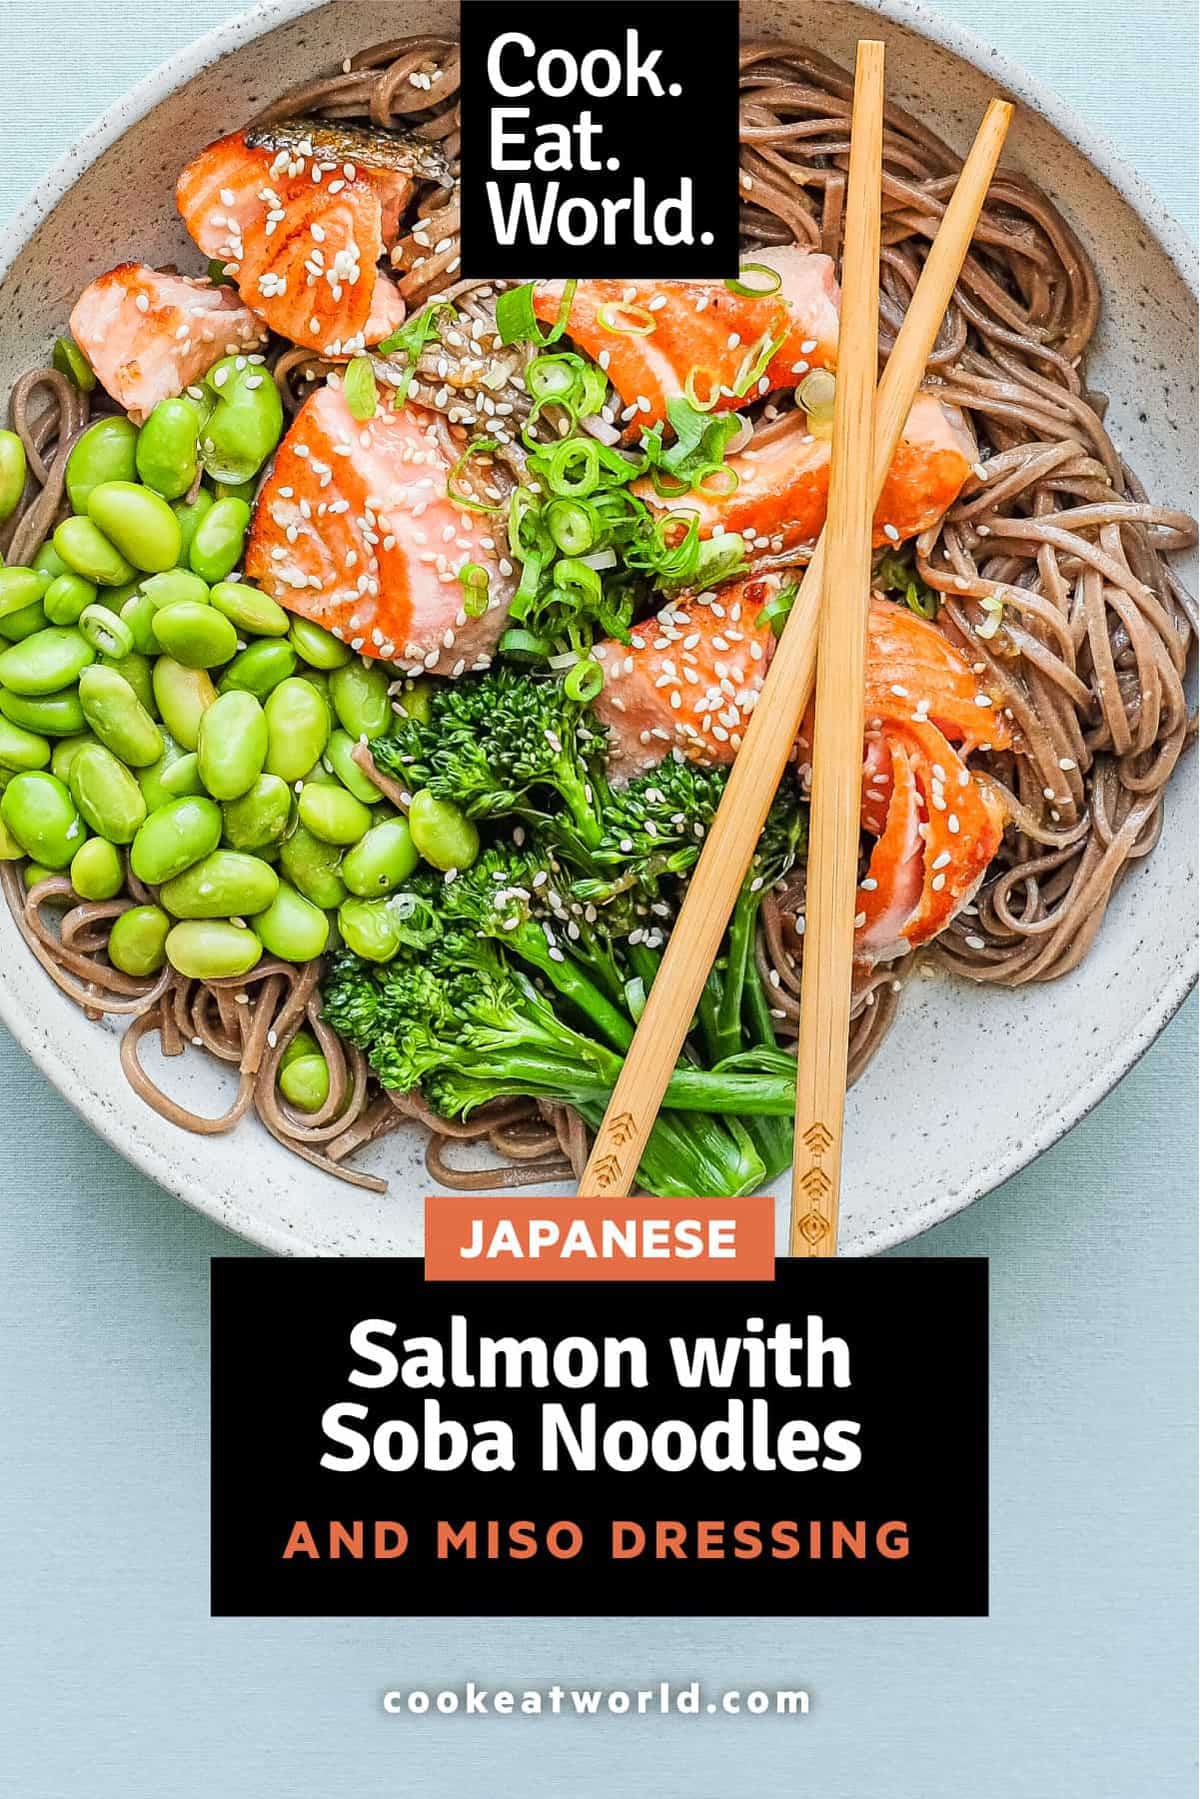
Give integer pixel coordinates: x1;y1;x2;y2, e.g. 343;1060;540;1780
246;383;511;676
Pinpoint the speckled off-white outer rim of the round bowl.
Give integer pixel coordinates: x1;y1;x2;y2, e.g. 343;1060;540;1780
0;0;1198;1256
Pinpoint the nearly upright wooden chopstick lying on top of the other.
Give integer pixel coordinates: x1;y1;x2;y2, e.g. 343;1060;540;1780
788;40;883;1256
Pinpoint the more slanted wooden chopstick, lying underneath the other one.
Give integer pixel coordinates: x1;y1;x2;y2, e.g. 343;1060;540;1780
579;101;1013;1198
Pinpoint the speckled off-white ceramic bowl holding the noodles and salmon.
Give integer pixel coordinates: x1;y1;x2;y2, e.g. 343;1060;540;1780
0;0;1196;1254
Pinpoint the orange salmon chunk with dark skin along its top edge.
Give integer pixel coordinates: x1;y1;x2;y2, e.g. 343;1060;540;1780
175;121;447;356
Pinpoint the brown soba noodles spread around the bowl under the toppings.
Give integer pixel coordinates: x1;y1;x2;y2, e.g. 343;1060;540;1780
2;38;1196;1189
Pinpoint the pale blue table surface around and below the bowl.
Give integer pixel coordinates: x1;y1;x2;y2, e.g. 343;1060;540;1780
0;0;1196;1799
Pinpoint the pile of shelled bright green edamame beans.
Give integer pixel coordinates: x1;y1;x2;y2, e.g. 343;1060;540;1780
0;356;479;1110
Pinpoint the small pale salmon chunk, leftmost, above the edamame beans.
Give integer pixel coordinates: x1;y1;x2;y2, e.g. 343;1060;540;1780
70;263;266;425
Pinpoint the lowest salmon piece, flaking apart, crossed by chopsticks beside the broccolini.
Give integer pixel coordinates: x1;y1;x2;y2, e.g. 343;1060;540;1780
596;574;1011;964
